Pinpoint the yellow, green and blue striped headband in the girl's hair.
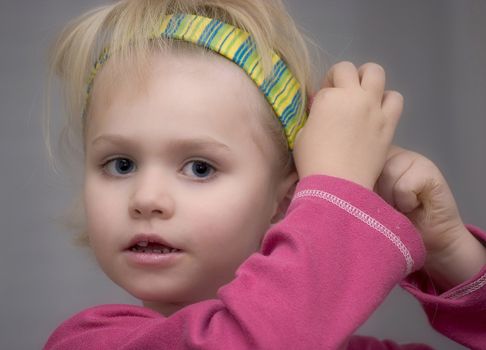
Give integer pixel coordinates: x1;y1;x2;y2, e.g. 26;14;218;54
85;14;307;150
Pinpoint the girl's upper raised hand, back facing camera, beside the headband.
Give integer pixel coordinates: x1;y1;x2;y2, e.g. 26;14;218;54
294;62;403;189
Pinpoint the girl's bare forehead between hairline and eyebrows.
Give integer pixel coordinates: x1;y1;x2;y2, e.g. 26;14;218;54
87;50;274;152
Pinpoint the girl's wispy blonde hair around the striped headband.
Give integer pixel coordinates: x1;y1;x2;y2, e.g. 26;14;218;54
45;0;314;245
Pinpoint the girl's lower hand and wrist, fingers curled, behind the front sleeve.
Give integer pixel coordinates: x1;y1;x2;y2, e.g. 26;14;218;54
375;146;486;291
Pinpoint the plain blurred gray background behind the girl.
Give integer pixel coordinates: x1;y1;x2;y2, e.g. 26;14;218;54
0;0;486;349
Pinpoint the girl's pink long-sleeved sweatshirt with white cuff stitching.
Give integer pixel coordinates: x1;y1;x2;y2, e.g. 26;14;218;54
45;176;486;350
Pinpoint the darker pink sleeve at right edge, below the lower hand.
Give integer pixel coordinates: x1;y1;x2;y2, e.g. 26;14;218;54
401;225;486;350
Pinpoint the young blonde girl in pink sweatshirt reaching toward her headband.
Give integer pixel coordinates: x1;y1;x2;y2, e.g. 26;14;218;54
45;0;486;349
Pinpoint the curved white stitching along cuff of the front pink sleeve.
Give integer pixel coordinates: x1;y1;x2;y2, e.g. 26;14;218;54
294;190;414;275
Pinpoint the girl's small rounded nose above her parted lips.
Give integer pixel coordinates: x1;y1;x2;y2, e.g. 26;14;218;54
129;172;175;219
